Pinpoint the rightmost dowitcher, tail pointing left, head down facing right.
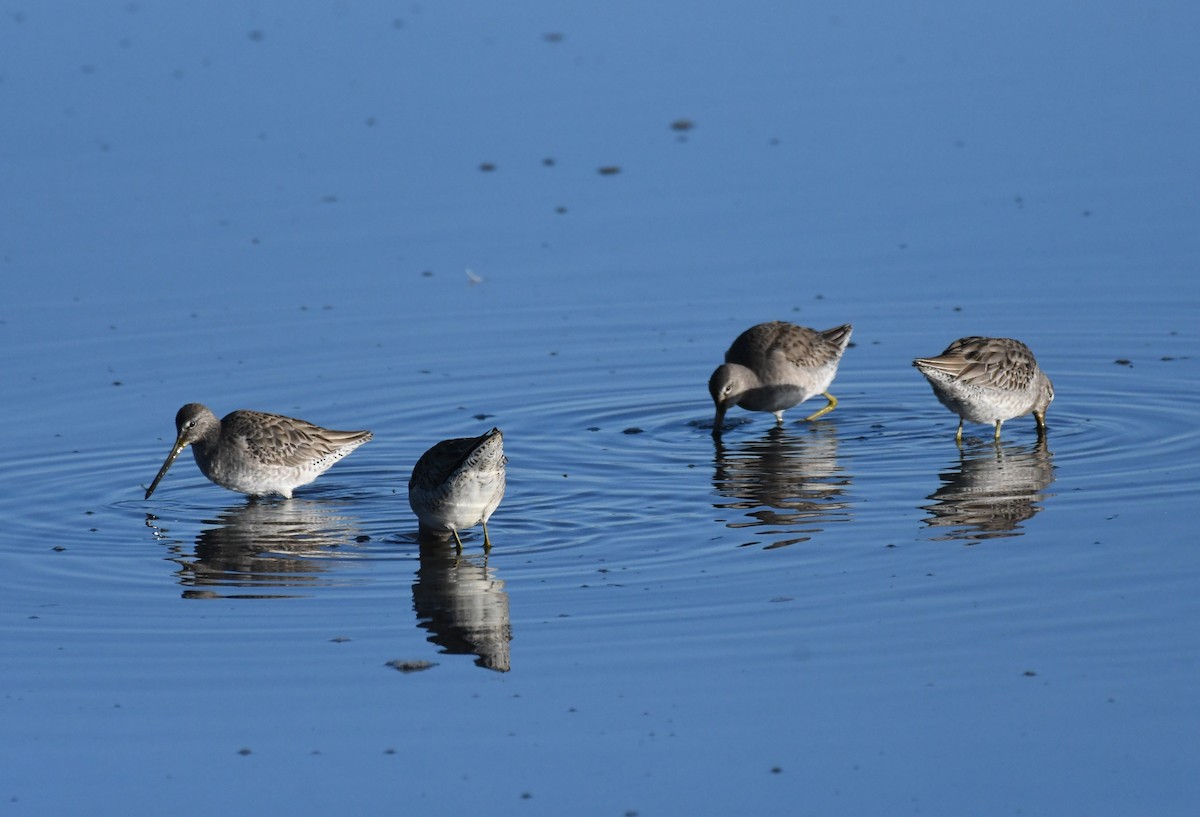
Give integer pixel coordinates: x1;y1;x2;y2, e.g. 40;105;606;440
912;337;1054;445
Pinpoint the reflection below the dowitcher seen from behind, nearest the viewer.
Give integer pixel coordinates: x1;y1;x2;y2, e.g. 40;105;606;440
413;539;512;672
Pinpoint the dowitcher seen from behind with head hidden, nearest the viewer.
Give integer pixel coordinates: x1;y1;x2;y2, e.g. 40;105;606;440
408;428;508;551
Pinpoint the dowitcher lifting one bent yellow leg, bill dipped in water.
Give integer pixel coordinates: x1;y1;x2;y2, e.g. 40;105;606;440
708;320;853;437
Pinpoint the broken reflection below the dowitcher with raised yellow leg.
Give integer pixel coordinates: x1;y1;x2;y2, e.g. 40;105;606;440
713;423;852;548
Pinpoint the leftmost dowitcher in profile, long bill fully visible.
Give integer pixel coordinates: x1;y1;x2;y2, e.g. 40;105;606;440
146;403;371;499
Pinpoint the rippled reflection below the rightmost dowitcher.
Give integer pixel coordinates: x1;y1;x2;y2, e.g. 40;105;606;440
923;438;1054;537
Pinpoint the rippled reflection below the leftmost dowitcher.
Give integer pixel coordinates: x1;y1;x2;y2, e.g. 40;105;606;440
146;499;359;599
